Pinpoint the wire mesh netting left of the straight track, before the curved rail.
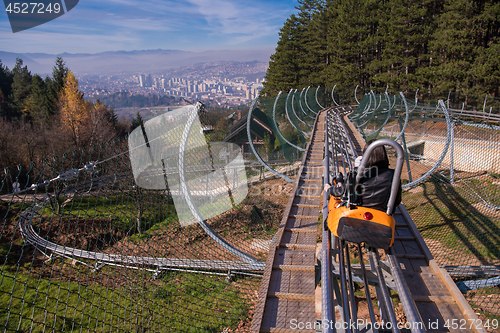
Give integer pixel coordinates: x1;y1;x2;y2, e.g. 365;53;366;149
0;105;304;332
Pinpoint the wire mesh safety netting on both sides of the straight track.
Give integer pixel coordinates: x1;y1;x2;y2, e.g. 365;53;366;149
0;87;500;332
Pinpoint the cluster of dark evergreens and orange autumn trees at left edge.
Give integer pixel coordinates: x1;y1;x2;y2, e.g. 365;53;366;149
0;57;121;191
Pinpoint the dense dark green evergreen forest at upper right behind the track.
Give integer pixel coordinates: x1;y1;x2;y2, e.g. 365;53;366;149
262;0;500;97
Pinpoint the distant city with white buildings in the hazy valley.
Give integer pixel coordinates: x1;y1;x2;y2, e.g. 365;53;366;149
78;61;268;106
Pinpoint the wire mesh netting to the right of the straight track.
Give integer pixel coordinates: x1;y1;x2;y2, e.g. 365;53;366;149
350;92;500;318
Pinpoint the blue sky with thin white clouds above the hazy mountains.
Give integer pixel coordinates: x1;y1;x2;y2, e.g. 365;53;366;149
0;0;297;54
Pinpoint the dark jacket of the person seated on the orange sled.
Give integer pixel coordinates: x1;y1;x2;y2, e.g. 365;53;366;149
356;167;401;212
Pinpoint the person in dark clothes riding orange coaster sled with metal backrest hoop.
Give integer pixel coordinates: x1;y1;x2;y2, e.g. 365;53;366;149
325;139;403;250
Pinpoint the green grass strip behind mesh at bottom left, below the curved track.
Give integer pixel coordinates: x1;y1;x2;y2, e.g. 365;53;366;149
0;246;249;332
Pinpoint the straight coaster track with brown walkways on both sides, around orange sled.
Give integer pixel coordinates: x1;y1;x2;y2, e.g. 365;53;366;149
251;100;483;333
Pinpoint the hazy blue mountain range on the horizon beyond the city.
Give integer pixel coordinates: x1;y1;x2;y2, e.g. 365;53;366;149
0;49;273;75
